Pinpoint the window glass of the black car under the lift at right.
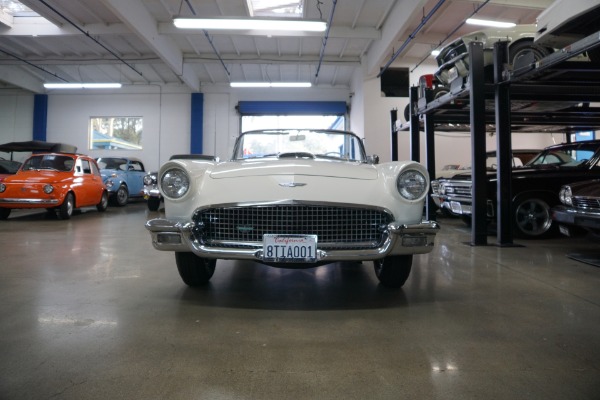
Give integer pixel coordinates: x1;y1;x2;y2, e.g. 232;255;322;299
526;142;599;168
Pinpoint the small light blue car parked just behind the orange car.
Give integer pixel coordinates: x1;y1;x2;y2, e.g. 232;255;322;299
96;157;146;207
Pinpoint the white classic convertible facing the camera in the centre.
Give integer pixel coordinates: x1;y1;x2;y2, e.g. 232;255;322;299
146;130;439;287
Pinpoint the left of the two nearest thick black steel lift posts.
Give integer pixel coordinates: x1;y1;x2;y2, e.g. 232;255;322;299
469;42;487;246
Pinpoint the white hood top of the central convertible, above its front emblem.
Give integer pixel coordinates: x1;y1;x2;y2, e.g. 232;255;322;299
210;159;378;180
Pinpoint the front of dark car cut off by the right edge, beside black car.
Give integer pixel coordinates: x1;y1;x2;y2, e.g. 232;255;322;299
552;179;600;237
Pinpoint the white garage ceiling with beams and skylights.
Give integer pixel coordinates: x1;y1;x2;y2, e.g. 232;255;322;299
0;0;553;93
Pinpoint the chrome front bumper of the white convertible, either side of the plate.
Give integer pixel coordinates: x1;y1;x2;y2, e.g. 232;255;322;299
146;218;440;262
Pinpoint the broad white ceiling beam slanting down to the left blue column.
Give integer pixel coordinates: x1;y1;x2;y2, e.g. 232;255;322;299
100;0;200;91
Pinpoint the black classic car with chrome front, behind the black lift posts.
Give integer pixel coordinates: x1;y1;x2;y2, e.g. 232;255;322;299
431;140;600;239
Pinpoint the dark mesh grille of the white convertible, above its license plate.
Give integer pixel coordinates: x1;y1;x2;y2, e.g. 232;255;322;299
193;204;392;249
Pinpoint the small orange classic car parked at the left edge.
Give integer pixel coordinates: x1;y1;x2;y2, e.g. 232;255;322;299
0;153;108;219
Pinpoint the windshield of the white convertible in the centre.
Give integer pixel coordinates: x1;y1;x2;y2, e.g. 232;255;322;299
233;130;366;162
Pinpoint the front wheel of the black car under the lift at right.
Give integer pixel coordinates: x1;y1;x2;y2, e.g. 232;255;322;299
514;197;557;239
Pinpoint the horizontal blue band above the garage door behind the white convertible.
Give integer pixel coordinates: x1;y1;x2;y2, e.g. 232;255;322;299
238;101;348;115
